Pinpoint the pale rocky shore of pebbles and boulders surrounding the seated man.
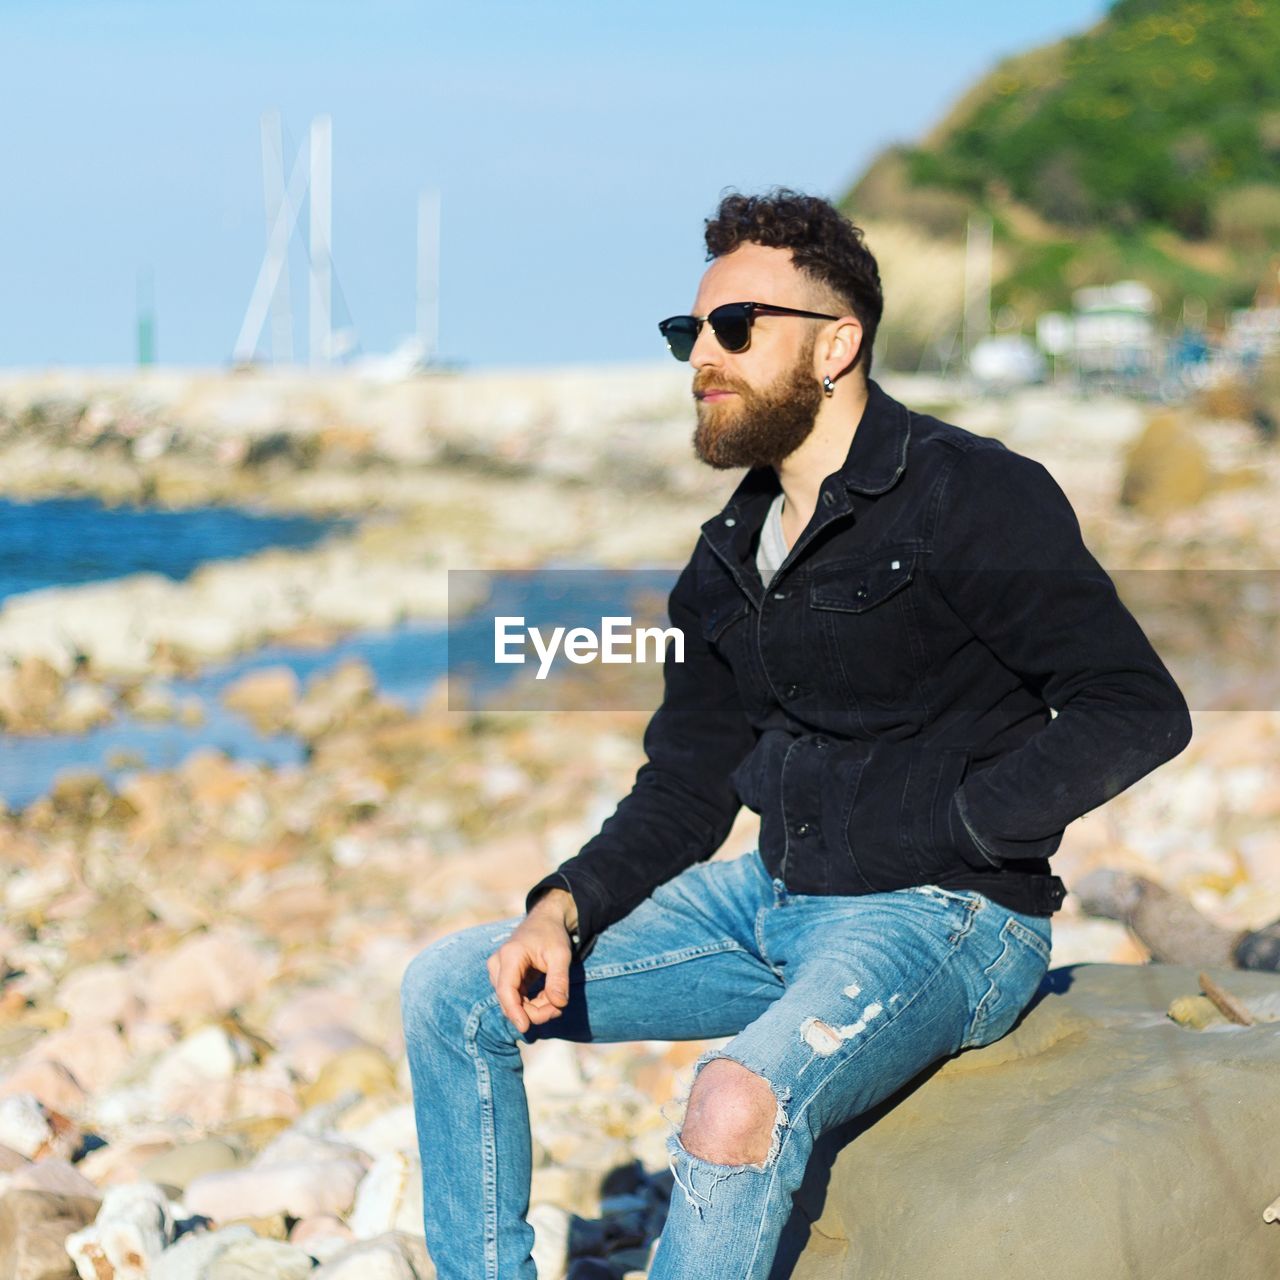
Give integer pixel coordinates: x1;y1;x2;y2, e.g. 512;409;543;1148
0;374;1280;1280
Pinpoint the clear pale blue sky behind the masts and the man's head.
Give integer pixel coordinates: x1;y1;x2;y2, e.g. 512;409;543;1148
0;0;1107;367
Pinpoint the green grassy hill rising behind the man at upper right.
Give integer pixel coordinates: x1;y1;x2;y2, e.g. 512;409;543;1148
844;0;1280;355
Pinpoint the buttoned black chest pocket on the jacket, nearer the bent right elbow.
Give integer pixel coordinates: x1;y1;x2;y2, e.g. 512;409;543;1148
809;548;919;703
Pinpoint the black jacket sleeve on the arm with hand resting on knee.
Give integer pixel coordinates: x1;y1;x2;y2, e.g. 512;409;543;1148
525;553;755;959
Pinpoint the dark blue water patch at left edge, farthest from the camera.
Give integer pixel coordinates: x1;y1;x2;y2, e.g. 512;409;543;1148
0;498;349;600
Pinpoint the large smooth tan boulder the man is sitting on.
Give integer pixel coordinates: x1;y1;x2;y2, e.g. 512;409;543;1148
795;965;1280;1280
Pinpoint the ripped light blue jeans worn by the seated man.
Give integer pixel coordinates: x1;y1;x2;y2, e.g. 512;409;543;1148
402;852;1050;1280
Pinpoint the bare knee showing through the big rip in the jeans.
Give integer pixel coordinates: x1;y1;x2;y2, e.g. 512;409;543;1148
680;1057;778;1165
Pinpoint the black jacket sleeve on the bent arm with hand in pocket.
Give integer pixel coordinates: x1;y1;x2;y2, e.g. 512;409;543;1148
933;447;1192;867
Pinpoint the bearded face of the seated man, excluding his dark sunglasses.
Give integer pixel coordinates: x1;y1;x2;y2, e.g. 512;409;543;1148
690;244;826;470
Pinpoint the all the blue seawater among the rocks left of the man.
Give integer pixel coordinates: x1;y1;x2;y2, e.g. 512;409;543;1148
0;499;676;808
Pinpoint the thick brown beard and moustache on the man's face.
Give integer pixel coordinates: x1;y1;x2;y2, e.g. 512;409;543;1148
694;344;822;471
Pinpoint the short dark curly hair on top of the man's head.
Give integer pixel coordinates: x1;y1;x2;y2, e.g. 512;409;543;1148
705;187;884;378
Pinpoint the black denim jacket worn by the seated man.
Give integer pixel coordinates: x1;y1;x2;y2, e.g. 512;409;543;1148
526;381;1190;957
